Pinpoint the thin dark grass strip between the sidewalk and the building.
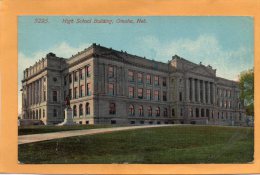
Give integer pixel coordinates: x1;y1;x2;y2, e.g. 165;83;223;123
18;125;126;135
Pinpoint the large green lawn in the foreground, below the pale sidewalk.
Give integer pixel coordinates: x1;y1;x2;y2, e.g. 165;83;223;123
19;126;254;164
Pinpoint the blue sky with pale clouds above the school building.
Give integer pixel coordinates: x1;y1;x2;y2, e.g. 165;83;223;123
18;16;254;113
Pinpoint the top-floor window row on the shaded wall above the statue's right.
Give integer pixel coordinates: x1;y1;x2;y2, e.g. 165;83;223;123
64;65;91;85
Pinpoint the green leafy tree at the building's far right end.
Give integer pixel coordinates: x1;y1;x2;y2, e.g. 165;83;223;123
239;69;254;116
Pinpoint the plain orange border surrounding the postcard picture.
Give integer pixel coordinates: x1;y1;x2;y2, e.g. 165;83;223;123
0;0;260;174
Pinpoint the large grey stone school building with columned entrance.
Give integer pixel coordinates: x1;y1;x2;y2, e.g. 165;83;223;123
21;44;245;125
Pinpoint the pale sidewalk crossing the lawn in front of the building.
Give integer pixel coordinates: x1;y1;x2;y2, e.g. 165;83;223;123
18;124;176;145
